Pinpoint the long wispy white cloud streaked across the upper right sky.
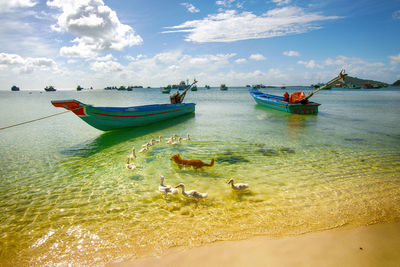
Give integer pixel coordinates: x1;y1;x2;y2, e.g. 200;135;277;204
163;6;339;43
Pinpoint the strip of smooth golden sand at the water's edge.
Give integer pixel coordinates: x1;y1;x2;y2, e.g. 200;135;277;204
106;222;400;267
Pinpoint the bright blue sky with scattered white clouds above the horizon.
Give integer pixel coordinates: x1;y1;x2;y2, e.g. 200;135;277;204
0;0;400;90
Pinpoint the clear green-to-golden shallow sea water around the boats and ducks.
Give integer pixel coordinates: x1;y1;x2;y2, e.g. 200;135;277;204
0;87;400;266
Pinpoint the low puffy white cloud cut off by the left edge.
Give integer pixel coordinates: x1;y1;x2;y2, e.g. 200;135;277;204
0;53;57;74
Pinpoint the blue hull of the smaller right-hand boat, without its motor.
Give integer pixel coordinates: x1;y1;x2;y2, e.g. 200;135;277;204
249;89;321;114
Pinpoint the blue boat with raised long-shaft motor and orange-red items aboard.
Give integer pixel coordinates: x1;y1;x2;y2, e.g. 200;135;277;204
249;70;347;114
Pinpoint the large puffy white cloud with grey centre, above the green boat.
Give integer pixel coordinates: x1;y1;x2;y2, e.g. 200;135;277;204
47;0;143;58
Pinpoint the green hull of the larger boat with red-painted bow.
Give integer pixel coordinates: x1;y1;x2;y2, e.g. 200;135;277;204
51;99;196;131
